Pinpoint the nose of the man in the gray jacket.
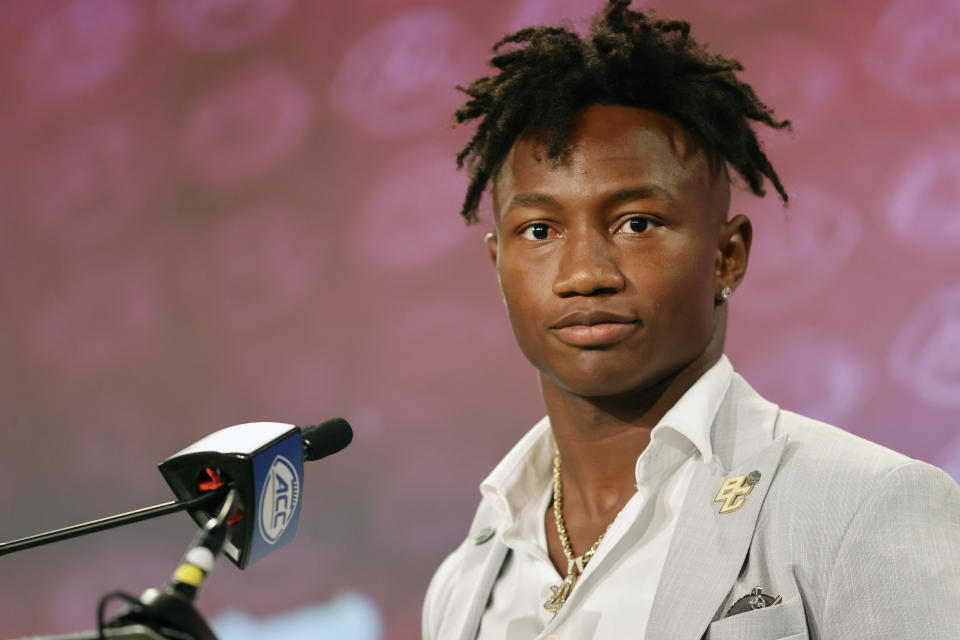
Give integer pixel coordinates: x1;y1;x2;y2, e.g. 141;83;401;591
553;230;625;297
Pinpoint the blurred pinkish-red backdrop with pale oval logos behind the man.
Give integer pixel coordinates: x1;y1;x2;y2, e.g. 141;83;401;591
0;0;960;639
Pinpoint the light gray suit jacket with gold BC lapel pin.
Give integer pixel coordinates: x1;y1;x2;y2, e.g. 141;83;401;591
423;374;960;640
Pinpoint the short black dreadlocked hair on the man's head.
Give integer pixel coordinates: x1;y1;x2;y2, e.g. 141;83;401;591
455;0;790;224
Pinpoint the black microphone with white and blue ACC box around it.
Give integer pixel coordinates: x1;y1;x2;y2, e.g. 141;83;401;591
159;418;353;569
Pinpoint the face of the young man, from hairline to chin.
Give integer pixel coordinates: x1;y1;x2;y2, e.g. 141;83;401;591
488;105;729;397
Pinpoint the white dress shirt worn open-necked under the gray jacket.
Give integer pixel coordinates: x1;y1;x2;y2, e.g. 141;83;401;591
477;356;733;640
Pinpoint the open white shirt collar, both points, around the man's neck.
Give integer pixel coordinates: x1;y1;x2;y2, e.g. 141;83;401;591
480;355;733;520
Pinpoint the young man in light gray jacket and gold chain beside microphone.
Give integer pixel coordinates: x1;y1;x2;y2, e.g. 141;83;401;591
423;0;960;640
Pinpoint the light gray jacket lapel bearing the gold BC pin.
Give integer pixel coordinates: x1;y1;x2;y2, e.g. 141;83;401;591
646;375;787;640
